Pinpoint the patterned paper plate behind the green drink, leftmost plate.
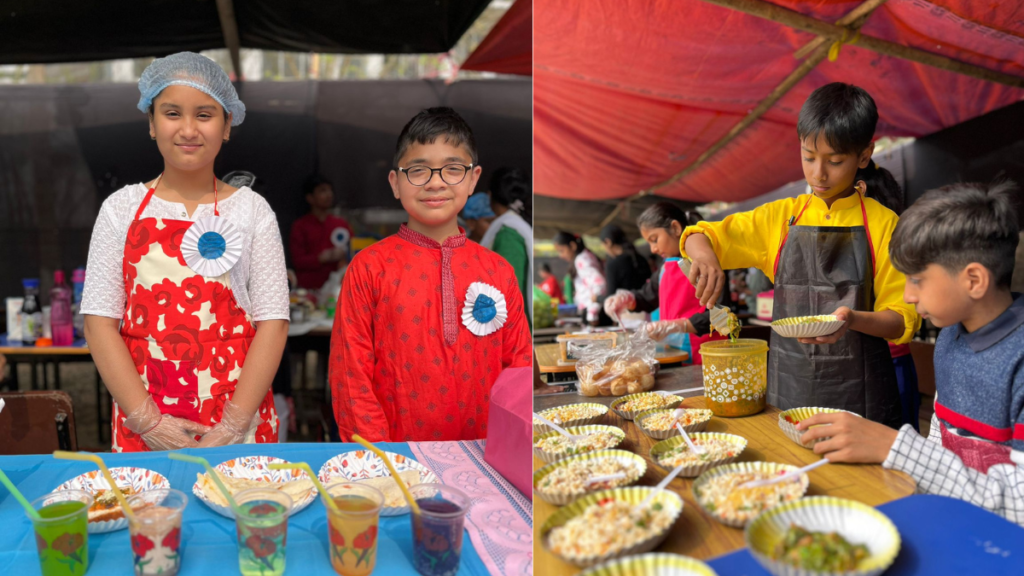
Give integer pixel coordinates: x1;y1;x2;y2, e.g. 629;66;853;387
54;466;171;534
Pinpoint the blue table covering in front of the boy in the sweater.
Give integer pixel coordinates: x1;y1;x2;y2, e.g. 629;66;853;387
708;494;1024;576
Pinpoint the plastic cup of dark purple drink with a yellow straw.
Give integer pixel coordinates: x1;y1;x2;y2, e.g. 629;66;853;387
409;484;469;576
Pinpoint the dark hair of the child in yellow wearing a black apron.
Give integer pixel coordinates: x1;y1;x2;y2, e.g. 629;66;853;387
797;82;879;154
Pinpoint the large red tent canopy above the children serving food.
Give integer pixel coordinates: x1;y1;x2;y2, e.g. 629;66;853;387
534;0;1024;202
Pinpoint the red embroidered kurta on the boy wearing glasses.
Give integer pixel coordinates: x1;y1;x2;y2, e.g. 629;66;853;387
330;225;532;442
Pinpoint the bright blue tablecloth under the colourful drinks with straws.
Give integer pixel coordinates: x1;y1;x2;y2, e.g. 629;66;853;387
0;443;488;576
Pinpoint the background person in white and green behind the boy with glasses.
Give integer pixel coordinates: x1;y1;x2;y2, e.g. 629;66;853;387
480;167;534;326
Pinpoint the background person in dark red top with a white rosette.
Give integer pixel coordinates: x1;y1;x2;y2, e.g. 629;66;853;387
288;175;352;290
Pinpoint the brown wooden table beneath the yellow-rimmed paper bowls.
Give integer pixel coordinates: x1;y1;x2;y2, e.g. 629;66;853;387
534;366;914;576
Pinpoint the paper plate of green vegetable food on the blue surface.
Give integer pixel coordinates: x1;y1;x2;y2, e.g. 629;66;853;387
744;496;900;576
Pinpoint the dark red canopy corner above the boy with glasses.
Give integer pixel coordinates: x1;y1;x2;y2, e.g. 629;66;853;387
462;0;534;76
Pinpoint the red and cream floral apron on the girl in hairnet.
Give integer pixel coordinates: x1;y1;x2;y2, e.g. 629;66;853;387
111;180;278;452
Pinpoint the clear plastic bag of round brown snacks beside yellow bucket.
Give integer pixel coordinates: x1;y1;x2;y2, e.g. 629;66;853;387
575;330;658;396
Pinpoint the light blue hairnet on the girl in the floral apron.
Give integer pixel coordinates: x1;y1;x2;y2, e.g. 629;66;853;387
138;52;246;126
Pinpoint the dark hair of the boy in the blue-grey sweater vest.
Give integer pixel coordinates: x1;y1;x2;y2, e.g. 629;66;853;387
889;181;1020;288
